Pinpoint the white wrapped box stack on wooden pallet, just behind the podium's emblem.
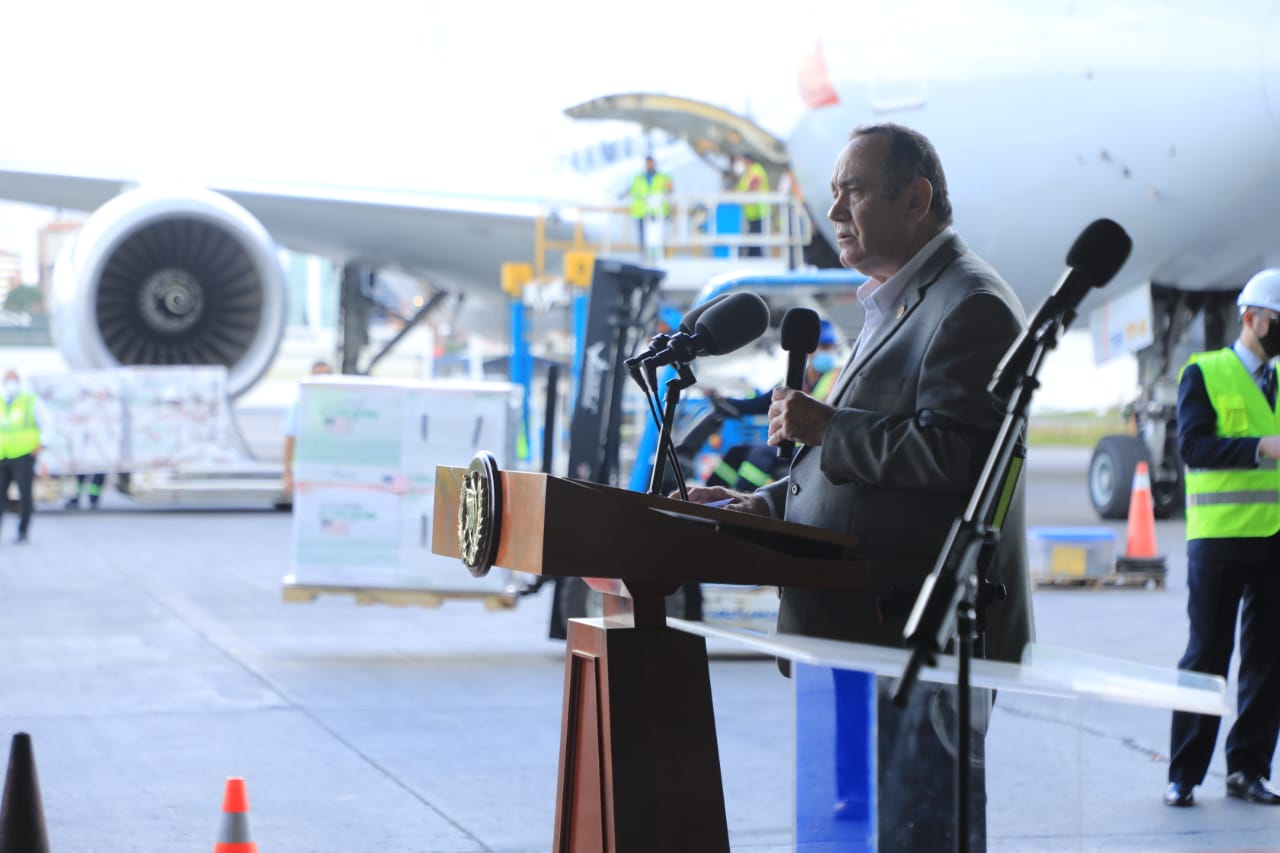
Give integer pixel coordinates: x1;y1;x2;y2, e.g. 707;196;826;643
288;377;518;594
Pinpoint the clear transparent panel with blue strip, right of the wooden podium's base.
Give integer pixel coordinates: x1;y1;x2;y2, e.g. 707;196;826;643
671;620;1233;853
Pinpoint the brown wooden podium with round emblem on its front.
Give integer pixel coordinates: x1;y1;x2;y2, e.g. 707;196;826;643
431;465;867;853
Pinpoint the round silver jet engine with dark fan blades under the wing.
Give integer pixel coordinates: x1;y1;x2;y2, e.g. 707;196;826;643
52;188;287;397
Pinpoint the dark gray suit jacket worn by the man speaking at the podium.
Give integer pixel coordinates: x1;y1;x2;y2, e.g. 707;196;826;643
762;237;1033;661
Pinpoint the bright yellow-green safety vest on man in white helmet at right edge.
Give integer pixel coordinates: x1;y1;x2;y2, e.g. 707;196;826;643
1183;348;1280;539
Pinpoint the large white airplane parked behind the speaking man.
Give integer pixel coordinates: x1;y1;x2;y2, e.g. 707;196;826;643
0;0;1280;517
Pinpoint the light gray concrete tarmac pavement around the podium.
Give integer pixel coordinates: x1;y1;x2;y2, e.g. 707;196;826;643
0;448;1280;853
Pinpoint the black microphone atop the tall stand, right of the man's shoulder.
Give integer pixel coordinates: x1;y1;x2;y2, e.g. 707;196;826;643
987;219;1133;403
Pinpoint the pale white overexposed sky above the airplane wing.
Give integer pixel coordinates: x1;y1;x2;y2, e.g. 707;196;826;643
0;0;1133;406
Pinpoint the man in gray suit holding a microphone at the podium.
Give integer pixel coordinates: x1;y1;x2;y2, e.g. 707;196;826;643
690;124;1032;850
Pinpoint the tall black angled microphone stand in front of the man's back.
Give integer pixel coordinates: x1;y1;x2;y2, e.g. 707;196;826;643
892;300;1075;853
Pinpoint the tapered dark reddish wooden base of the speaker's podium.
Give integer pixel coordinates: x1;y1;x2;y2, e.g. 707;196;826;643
553;619;730;853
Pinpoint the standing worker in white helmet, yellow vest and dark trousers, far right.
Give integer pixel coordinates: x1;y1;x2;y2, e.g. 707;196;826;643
1165;269;1280;806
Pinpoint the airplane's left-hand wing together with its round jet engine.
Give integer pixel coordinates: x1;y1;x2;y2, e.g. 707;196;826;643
0;164;573;394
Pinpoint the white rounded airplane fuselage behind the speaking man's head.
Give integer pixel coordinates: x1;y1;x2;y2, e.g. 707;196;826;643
786;1;1280;310
